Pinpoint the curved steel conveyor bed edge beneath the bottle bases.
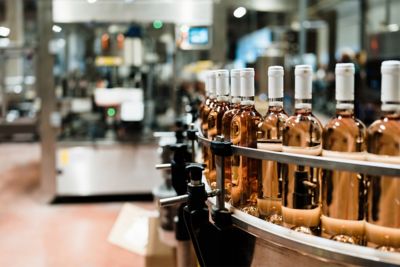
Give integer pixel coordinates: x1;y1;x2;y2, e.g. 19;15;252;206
204;195;400;267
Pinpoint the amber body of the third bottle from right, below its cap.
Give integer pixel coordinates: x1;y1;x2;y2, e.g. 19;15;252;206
282;103;322;235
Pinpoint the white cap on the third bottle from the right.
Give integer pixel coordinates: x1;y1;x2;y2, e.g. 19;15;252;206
294;65;312;99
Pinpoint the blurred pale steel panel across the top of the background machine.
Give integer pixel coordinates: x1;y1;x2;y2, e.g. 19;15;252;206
54;0;213;25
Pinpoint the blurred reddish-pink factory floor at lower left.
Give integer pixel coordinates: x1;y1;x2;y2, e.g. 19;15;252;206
0;144;154;267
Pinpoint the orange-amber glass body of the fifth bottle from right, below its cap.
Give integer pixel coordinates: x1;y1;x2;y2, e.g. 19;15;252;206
230;97;261;216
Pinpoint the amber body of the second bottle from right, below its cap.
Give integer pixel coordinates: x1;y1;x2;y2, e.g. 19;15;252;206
321;108;366;245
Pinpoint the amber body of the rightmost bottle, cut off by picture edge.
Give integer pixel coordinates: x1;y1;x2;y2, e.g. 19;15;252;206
365;110;400;252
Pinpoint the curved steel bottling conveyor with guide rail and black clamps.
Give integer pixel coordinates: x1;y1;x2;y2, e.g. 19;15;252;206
157;127;400;266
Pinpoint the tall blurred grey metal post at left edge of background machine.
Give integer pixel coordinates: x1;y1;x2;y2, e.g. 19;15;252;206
36;0;56;200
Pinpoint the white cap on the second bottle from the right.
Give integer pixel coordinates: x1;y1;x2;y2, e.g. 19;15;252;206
335;63;354;101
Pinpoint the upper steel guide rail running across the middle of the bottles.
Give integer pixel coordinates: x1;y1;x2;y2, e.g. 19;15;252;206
198;135;400;178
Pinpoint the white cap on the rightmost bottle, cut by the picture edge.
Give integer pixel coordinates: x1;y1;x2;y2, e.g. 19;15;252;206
381;60;400;102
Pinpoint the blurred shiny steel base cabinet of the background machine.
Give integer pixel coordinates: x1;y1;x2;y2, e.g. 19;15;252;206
57;144;162;196
